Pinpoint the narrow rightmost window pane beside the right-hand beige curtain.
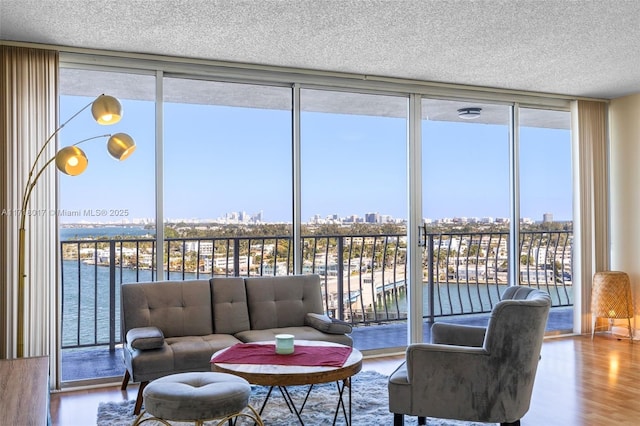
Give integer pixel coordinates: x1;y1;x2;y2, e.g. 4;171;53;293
518;108;574;329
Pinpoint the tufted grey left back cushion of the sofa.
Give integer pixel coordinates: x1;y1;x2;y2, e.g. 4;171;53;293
122;280;213;338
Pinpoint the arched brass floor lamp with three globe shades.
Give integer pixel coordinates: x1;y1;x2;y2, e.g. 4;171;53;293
17;95;136;358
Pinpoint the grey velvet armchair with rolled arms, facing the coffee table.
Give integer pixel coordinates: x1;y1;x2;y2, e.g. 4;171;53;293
388;286;551;426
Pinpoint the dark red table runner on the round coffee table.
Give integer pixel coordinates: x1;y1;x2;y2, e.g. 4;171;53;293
211;343;351;367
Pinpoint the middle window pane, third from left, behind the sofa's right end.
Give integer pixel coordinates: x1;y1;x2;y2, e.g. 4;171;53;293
300;89;408;349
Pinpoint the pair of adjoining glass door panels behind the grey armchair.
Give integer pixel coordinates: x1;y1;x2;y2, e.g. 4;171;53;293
422;99;573;332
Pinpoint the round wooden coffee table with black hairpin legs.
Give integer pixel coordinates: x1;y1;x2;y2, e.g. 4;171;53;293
211;340;362;425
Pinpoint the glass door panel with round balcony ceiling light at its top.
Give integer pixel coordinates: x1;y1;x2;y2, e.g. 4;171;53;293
422;99;510;320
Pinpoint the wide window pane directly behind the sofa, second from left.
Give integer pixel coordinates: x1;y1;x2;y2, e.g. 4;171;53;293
163;78;293;279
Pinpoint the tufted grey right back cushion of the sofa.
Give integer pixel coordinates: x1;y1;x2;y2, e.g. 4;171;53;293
245;275;324;330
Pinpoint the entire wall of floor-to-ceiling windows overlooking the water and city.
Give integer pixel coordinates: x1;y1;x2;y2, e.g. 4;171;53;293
59;57;572;380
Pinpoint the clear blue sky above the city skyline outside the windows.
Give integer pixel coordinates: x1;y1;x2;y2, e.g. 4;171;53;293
59;96;571;223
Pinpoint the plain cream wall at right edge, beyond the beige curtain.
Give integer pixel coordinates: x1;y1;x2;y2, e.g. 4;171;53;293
609;94;640;326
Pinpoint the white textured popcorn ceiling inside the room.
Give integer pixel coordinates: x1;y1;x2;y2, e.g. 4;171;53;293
0;0;640;99
